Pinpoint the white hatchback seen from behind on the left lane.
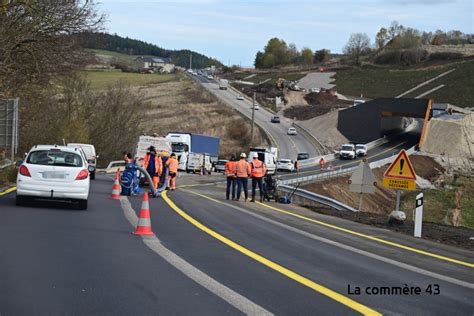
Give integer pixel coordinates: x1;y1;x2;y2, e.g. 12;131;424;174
16;145;90;210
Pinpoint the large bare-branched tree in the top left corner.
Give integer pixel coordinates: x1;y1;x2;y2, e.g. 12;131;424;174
0;0;104;96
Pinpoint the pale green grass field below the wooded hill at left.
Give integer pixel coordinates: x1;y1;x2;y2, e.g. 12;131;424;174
80;71;177;90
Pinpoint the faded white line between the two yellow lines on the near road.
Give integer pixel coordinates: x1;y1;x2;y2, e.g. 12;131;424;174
188;190;474;289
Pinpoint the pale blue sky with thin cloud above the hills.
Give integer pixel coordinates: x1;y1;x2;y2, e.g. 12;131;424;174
98;0;474;67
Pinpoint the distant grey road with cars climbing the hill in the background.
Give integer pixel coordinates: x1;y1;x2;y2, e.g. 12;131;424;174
192;76;319;160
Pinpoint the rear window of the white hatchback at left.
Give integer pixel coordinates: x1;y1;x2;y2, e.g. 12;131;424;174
26;149;82;167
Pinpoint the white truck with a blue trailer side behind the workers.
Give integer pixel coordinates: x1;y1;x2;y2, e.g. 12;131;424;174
166;132;220;171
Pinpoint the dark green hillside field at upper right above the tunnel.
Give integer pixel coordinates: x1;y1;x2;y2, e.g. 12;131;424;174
335;59;474;107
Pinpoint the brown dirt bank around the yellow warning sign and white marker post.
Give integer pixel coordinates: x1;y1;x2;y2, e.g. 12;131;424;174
304;155;474;250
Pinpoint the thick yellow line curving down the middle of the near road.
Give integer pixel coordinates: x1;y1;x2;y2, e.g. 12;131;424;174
161;191;381;315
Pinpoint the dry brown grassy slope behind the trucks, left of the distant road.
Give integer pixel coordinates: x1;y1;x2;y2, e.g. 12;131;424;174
134;78;266;157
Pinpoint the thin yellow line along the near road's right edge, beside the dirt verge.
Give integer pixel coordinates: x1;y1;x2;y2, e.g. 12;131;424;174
257;202;474;268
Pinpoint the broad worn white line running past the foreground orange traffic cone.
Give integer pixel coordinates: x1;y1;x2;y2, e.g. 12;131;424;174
120;197;273;315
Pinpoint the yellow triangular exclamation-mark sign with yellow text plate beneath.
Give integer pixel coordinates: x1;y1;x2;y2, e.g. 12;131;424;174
383;150;416;190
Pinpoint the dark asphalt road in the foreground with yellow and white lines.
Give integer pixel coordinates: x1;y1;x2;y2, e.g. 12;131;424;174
0;175;474;315
